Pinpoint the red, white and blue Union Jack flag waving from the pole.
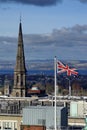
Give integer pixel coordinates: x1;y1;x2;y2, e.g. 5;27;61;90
57;61;78;76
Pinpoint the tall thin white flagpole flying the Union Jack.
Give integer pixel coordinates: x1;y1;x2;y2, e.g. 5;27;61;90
54;56;57;130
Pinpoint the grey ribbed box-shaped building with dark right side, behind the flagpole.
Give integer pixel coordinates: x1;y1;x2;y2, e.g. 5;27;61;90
22;106;68;130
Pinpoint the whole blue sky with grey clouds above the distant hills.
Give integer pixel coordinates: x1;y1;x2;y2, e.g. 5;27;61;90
0;0;87;61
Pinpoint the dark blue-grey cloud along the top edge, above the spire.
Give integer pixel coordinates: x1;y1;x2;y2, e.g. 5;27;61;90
0;0;62;6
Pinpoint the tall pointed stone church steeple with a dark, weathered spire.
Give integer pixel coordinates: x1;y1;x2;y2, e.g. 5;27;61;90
12;21;26;97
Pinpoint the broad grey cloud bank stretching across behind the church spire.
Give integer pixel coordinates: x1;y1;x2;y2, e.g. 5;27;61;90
0;24;87;60
